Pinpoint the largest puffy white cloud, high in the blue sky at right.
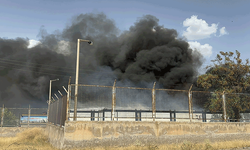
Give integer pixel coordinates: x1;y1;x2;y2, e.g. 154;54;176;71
183;15;218;40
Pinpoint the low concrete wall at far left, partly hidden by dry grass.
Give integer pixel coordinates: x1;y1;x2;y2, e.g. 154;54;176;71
0;127;45;137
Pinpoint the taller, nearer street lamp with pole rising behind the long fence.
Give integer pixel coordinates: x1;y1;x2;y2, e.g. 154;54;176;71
74;39;93;121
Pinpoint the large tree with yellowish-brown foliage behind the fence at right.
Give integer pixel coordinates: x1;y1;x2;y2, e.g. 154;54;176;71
197;50;250;121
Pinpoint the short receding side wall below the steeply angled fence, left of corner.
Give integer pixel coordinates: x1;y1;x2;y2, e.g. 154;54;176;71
45;124;64;148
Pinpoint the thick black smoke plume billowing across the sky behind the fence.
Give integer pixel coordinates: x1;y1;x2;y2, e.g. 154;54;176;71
0;13;202;107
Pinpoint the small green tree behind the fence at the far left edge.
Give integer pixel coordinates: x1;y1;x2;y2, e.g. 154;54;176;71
0;108;17;126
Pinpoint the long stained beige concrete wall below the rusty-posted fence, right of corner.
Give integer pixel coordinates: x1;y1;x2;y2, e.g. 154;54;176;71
62;121;250;148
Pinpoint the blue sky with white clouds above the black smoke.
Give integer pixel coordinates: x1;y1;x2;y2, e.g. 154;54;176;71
0;0;250;74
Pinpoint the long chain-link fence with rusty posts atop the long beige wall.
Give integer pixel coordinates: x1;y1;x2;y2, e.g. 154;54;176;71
68;84;250;122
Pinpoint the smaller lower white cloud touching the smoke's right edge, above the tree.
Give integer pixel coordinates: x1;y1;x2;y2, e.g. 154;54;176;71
188;41;213;58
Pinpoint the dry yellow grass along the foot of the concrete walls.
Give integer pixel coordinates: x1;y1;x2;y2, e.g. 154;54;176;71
0;128;250;150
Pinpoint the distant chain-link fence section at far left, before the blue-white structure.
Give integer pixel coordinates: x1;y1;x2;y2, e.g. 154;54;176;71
0;105;47;127
